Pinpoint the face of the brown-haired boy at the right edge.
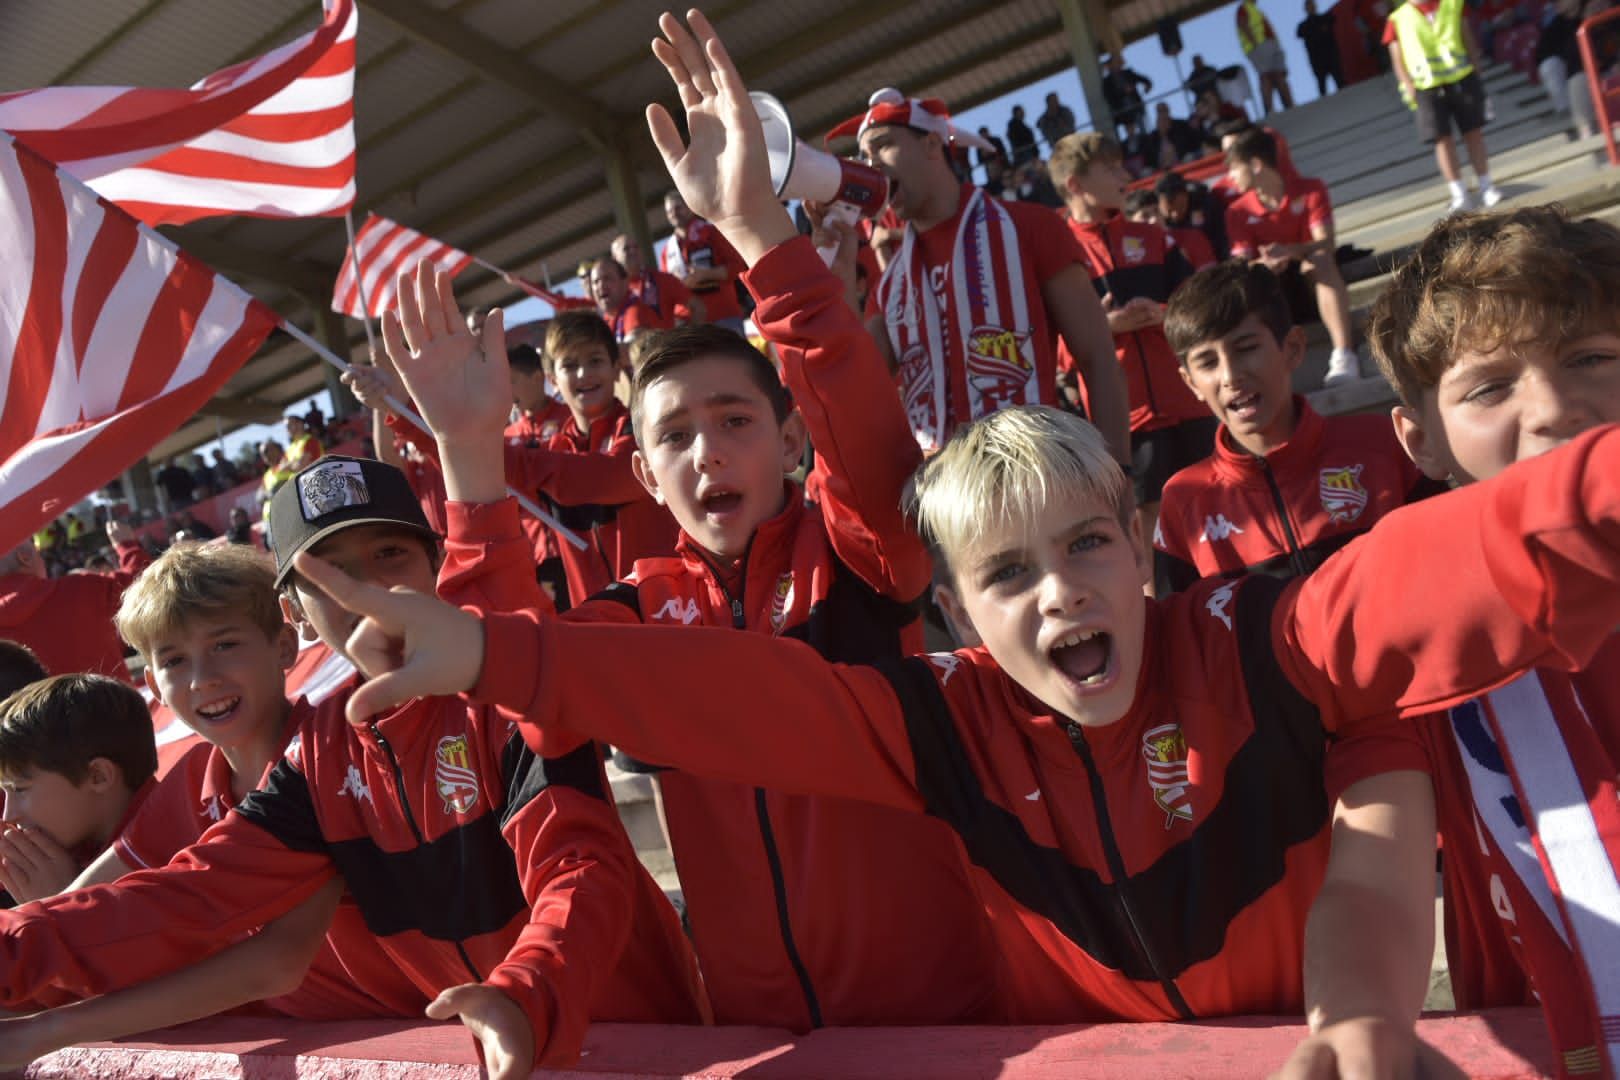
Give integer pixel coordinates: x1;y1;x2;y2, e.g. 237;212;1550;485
1395;334;1620;484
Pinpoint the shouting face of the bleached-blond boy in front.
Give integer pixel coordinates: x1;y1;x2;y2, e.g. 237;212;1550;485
951;497;1150;727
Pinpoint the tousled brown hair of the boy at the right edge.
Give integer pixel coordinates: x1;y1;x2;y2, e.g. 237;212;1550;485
1367;206;1620;408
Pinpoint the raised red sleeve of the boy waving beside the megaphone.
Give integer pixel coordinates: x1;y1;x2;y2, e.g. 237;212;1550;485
744;236;932;602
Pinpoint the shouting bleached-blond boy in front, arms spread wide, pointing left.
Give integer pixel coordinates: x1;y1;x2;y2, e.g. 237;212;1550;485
300;375;1620;1023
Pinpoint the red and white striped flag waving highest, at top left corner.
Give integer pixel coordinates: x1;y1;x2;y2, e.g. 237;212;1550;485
0;0;356;225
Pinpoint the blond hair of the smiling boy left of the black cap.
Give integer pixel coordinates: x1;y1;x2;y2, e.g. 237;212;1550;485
113;542;284;662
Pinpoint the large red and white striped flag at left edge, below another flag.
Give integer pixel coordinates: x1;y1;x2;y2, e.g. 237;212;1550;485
0;133;280;552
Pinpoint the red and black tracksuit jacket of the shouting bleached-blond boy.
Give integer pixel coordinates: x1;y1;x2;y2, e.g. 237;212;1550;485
473;429;1620;1023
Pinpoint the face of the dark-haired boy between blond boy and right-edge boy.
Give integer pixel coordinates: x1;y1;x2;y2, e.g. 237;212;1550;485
1181;314;1306;449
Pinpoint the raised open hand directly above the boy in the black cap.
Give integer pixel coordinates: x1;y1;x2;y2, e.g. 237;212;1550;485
382;259;512;444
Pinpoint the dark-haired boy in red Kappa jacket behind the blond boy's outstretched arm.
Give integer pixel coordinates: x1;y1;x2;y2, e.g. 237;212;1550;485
1153;261;1445;593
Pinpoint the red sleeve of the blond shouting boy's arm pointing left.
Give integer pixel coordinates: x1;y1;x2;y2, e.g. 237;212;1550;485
471;614;922;810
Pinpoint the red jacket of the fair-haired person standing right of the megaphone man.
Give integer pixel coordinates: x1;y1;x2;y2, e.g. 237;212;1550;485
1058;214;1210;432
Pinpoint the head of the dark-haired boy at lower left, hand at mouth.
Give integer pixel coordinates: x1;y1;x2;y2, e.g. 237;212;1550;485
0;674;157;904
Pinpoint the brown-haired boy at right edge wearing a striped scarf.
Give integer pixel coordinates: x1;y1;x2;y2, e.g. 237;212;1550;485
1285;207;1620;1077
